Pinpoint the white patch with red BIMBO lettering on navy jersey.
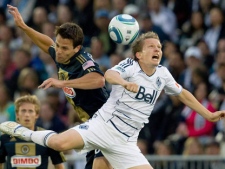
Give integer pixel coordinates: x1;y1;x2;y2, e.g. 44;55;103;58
11;155;41;168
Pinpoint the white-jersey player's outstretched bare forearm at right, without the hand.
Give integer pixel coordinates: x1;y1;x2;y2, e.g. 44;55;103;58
178;89;212;120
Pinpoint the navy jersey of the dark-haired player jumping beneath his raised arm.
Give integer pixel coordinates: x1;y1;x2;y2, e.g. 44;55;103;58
49;46;108;121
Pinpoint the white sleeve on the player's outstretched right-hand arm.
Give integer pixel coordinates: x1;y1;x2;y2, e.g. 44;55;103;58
164;67;183;95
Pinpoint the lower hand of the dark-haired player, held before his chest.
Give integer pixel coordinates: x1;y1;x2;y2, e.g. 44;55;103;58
38;78;64;89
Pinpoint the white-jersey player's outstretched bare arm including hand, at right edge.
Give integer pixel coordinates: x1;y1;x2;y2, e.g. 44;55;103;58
178;89;225;122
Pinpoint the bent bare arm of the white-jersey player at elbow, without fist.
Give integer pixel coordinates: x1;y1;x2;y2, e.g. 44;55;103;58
105;70;126;85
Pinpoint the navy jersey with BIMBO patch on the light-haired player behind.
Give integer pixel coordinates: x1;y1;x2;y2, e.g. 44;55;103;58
0;127;65;169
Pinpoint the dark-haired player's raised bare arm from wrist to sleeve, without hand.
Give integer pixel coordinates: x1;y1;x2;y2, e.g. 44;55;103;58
20;24;54;53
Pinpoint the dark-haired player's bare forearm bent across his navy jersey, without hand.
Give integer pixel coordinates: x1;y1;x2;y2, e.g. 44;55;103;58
63;72;105;89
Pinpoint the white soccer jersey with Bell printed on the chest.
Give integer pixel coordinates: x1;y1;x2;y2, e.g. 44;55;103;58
99;58;182;141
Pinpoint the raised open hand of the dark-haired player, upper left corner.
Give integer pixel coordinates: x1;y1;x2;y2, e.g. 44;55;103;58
7;4;25;28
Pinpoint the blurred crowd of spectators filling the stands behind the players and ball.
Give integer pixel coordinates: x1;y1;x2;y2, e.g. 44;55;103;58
0;0;225;165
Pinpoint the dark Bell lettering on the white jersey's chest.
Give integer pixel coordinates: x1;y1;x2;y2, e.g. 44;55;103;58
135;86;158;104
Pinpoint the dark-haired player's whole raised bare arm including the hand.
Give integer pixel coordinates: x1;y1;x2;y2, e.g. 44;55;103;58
7;5;54;53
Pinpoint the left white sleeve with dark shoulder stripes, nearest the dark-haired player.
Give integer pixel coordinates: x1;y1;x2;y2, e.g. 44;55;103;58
111;58;135;79
